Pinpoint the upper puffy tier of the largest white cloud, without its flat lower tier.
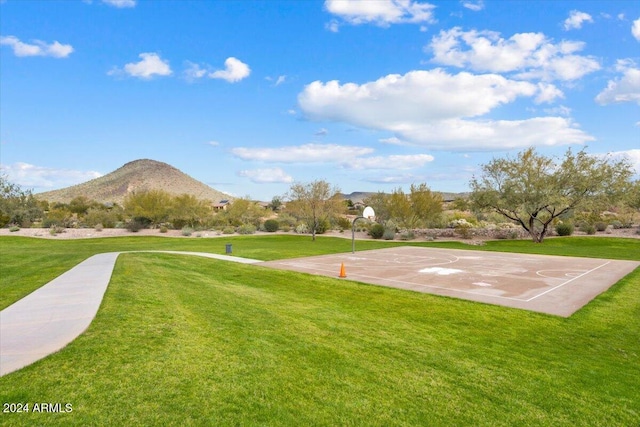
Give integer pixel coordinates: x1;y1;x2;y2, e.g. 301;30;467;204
298;69;538;123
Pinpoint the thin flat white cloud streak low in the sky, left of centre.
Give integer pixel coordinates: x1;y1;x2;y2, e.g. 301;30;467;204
231;144;373;163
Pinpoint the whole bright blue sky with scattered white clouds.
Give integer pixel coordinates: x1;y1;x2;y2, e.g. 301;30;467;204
0;0;640;200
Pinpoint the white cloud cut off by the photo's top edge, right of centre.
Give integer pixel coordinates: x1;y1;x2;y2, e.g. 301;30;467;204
324;0;435;27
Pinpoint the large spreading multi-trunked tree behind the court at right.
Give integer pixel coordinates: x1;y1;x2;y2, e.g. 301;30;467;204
470;148;633;243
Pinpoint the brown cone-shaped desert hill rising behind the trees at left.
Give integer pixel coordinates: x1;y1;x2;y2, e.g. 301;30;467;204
35;159;232;204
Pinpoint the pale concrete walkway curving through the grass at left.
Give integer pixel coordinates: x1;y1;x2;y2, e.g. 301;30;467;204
0;251;262;376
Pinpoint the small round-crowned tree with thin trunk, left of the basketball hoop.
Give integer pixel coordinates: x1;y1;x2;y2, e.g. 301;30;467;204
287;180;344;241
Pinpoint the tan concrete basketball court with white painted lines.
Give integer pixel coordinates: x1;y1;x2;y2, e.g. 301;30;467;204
260;246;640;317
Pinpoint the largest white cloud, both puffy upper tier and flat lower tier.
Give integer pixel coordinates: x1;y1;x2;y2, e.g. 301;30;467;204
298;69;593;151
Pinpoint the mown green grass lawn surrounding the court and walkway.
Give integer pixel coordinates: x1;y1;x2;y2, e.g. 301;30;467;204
0;236;640;426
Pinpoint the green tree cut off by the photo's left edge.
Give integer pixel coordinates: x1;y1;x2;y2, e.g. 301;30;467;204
0;175;42;227
